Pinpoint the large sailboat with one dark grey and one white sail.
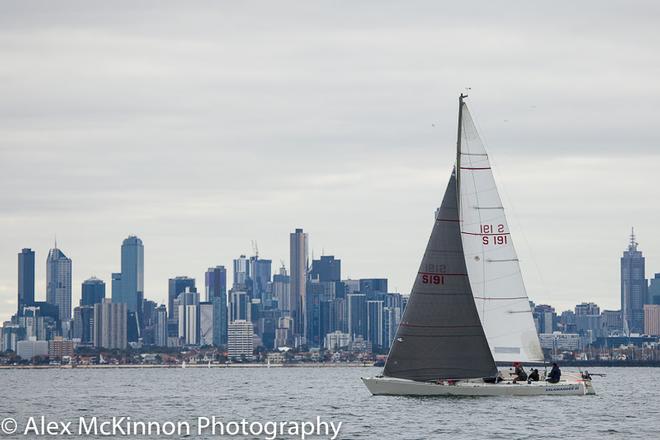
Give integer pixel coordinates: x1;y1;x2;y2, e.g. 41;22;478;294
362;94;595;396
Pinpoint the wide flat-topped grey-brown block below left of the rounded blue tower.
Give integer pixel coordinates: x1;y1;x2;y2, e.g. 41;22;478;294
94;298;128;350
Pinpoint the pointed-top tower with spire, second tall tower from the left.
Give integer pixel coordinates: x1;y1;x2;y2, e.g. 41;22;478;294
46;243;72;321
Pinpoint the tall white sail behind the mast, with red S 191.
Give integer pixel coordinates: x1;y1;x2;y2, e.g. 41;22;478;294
457;103;543;362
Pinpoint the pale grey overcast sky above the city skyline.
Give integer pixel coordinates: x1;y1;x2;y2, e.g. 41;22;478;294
0;1;660;320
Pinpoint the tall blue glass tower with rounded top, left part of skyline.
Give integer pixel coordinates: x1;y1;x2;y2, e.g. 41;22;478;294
118;235;144;314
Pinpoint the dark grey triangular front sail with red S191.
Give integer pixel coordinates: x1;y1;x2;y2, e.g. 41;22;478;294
383;173;497;381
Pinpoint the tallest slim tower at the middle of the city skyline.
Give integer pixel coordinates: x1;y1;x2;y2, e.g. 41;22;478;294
289;229;308;340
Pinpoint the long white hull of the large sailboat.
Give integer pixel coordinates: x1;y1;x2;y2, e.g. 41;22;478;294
362;377;596;396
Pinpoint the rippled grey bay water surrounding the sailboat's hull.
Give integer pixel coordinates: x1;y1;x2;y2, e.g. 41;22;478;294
0;368;660;440
